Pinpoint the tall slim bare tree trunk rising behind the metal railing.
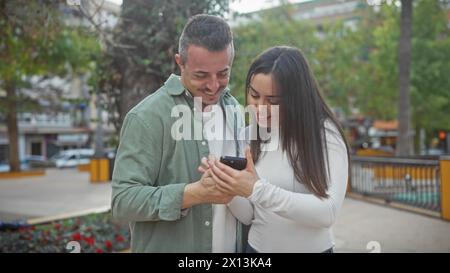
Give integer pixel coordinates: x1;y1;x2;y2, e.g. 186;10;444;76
396;0;412;156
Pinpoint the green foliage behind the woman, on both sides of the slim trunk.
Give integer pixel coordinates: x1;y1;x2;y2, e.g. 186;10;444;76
231;0;450;135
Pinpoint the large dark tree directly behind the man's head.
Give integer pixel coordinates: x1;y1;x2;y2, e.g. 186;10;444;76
100;0;228;131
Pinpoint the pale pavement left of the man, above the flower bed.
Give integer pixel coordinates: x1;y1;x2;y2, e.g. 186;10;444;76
0;169;111;221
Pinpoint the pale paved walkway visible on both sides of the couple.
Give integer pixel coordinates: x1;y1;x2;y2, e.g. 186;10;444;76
0;169;450;252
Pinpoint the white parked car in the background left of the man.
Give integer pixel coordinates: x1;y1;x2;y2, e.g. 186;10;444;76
50;149;94;168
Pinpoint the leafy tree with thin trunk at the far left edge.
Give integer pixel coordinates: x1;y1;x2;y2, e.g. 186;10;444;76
0;0;98;171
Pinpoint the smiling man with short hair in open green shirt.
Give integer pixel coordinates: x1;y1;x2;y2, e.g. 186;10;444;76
111;15;243;252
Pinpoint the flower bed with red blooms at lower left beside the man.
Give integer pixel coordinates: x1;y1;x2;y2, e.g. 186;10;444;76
0;212;130;253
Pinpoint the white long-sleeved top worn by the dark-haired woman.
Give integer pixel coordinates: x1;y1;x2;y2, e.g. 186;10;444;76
229;122;348;252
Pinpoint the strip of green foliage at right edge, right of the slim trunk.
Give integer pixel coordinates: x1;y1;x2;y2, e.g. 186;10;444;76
411;0;450;147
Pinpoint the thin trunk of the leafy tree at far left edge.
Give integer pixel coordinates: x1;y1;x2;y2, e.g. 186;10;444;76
5;82;20;172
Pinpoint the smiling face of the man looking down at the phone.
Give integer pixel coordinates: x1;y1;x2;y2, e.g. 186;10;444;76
175;45;232;106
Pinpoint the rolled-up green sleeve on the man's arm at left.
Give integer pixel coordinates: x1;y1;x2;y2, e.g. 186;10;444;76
111;113;186;221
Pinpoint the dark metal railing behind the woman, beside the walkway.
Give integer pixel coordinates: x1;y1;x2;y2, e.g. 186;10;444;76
349;156;441;212
